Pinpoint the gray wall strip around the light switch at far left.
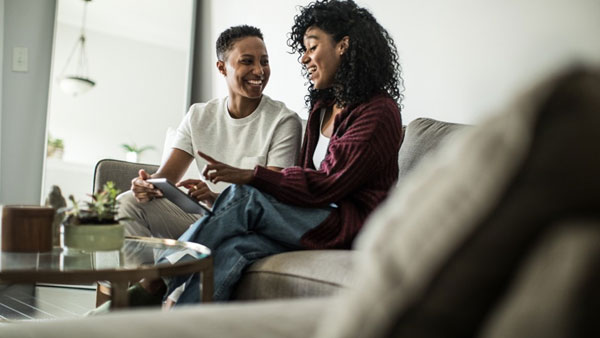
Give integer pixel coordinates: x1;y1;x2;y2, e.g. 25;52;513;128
0;0;56;204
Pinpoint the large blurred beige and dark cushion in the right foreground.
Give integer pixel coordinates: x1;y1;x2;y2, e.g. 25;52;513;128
319;71;600;337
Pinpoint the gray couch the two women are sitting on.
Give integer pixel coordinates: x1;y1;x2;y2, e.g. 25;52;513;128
94;118;463;300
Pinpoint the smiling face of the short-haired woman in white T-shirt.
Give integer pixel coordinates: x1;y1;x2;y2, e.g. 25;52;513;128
217;36;271;100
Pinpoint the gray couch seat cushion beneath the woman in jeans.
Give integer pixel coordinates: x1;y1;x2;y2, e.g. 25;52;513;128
234;250;356;300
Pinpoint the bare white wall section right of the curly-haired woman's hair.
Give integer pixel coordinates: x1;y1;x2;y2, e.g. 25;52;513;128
376;0;600;123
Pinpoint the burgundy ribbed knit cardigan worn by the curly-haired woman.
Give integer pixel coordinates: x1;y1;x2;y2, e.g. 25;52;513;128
251;95;403;249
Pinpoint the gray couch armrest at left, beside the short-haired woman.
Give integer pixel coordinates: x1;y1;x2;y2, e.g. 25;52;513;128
94;159;158;192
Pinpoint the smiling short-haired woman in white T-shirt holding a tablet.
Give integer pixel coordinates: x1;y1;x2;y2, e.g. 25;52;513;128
119;25;302;238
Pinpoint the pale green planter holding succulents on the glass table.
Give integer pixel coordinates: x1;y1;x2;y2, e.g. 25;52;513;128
64;223;125;251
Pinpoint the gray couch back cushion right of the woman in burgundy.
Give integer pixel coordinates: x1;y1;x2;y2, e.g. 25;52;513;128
398;117;468;184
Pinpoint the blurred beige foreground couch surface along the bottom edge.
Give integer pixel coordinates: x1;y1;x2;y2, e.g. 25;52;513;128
0;298;330;338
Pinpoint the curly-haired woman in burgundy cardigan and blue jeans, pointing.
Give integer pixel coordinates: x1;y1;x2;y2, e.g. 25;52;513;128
112;0;402;303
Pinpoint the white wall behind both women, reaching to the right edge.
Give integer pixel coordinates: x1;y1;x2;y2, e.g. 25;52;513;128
210;0;600;123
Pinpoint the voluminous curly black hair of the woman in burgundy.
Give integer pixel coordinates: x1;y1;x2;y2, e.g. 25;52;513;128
287;0;403;107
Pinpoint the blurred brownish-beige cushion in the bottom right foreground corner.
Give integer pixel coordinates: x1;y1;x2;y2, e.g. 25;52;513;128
481;218;600;338
